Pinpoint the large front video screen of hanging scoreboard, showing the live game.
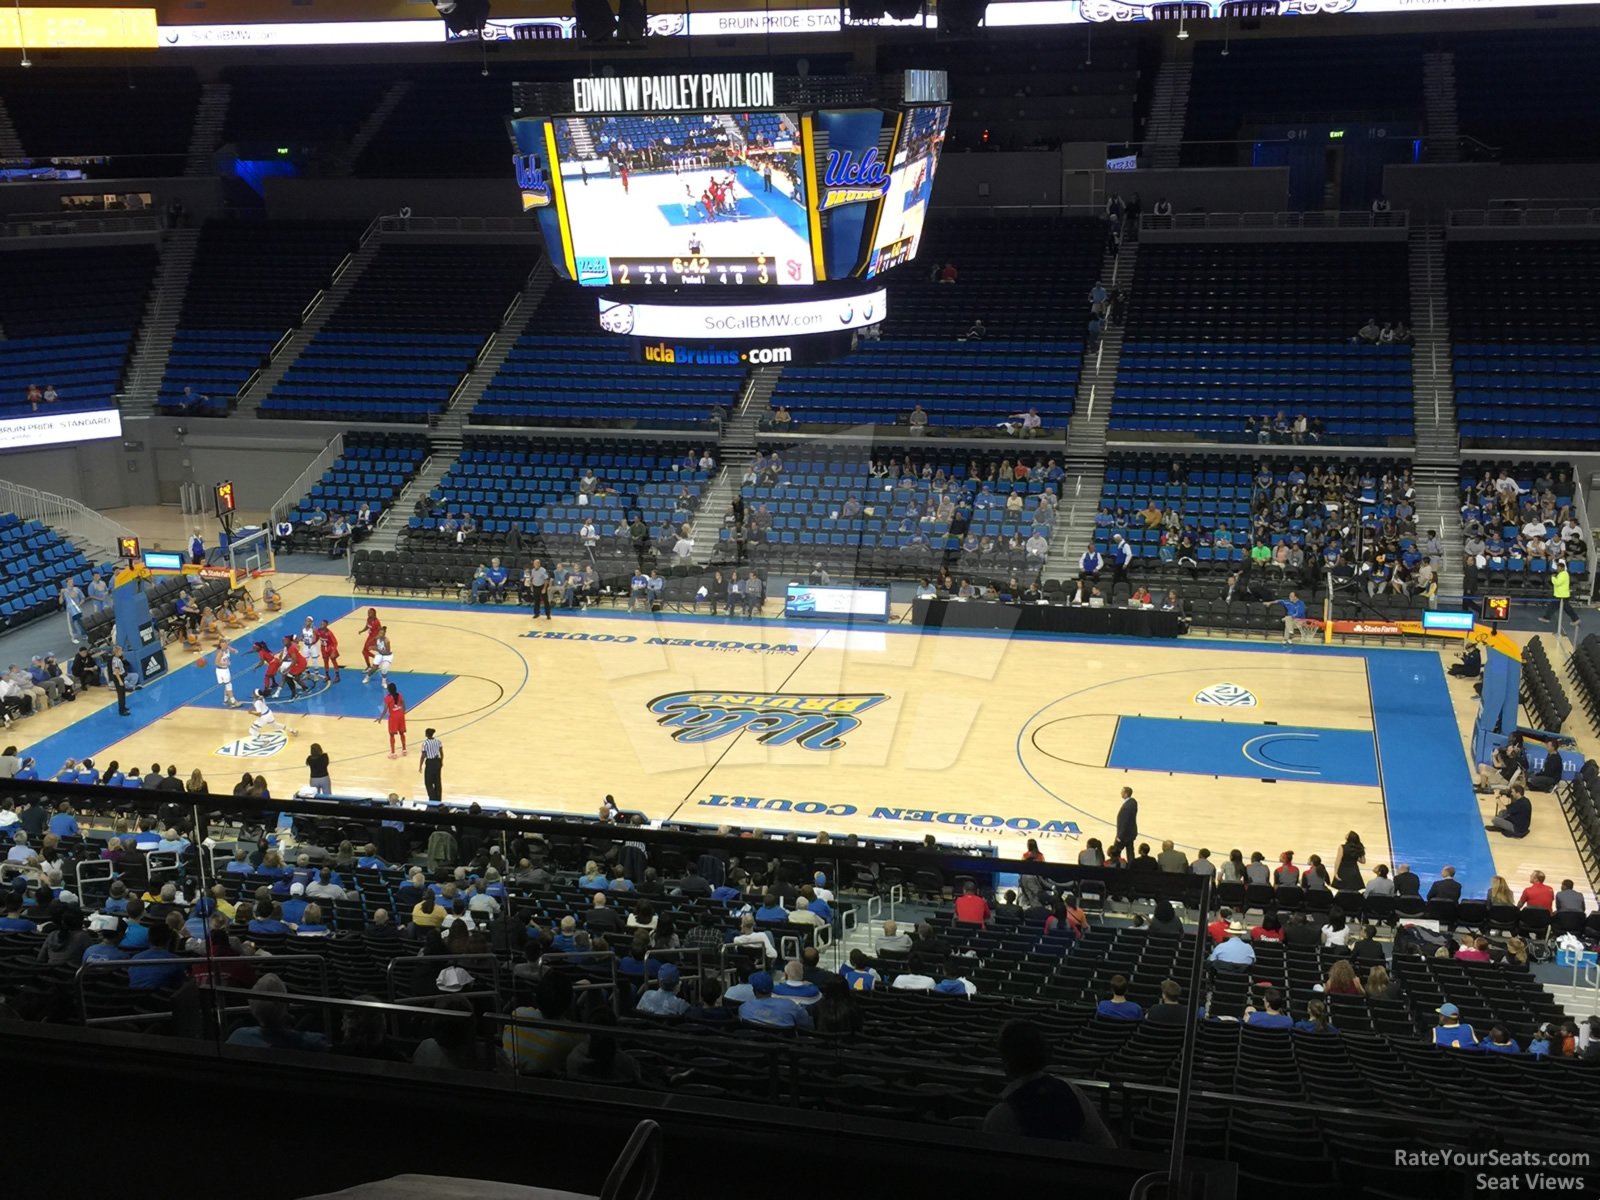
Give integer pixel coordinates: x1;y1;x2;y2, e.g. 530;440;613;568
552;112;816;286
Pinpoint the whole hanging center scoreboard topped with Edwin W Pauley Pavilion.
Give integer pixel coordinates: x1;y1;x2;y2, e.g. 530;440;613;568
509;72;950;365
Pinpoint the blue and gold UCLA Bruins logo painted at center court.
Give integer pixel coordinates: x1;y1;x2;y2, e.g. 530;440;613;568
648;691;888;750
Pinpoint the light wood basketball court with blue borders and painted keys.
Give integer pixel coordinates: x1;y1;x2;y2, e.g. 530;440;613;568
18;576;1582;894
